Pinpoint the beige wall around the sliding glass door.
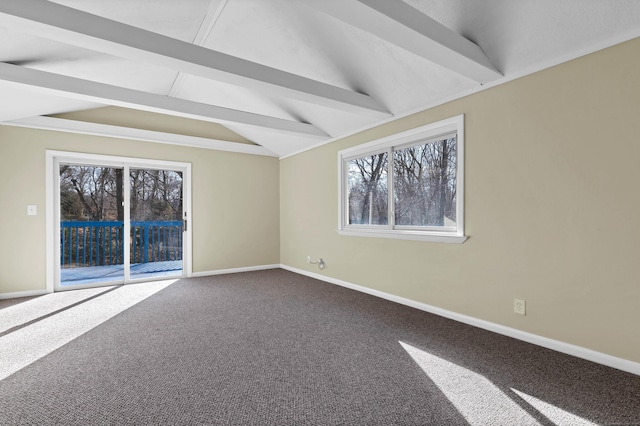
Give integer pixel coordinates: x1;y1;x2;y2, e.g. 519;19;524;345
0;126;279;293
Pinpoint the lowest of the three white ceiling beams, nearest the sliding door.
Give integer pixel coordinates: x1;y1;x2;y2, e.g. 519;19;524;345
0;62;328;139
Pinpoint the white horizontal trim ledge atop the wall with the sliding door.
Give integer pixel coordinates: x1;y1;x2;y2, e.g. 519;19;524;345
0;116;278;157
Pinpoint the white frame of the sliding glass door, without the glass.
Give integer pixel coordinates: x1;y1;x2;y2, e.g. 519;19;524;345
45;150;193;293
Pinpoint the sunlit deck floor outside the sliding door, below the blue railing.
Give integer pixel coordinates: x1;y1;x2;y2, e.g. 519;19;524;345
60;260;182;287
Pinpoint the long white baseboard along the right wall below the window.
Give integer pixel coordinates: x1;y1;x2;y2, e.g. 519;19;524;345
280;265;640;375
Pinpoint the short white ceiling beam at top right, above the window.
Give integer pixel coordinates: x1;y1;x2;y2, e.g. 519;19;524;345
302;0;502;83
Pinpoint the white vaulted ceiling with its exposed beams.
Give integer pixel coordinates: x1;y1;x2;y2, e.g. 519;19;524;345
0;0;640;157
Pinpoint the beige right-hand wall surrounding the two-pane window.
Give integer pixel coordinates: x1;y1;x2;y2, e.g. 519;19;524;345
280;39;640;362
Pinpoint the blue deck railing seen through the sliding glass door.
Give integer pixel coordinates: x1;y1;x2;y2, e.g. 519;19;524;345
60;220;182;268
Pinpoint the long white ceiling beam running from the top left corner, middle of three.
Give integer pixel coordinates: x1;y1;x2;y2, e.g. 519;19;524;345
0;0;390;117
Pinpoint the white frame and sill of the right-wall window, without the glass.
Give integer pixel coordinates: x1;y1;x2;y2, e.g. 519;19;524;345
338;115;468;244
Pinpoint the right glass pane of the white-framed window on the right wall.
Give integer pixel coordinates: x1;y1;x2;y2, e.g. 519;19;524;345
393;137;457;227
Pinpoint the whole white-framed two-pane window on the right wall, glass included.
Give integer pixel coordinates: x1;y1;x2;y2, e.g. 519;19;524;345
338;116;466;243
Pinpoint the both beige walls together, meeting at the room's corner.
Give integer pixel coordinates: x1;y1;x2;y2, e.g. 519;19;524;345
0;35;640;362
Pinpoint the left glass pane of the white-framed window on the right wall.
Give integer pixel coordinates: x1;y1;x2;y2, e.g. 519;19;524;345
347;152;389;225
